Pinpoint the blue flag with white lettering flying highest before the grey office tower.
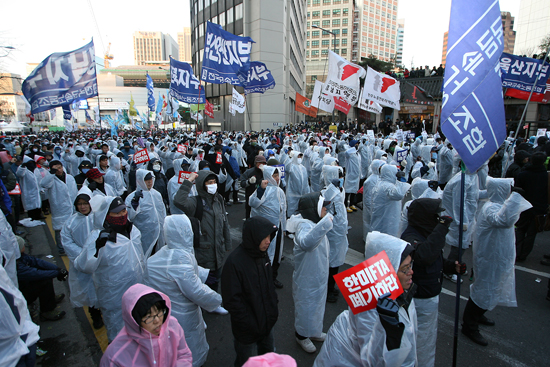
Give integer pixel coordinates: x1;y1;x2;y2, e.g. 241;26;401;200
201;22;254;85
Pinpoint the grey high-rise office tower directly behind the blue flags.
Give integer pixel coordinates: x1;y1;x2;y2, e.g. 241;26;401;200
190;0;306;131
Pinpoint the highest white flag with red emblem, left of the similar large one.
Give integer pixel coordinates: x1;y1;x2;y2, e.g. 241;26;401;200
323;50;365;107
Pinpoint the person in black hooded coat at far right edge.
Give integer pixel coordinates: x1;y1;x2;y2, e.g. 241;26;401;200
514;152;550;265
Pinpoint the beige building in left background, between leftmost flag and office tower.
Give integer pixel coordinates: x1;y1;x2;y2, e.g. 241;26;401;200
134;32;179;65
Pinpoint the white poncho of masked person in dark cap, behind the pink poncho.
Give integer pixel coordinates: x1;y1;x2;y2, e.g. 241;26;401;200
74;196;144;341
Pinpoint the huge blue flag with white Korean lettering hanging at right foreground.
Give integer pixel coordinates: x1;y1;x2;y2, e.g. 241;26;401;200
441;0;506;172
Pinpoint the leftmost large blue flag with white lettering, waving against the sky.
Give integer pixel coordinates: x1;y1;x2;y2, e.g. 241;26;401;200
22;41;97;113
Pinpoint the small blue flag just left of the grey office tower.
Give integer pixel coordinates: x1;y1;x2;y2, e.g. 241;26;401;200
170;58;205;104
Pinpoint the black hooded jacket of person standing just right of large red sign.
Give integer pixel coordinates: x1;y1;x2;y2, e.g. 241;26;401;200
401;198;455;298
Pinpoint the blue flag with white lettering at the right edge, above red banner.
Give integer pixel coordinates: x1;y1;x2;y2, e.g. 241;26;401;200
500;52;550;94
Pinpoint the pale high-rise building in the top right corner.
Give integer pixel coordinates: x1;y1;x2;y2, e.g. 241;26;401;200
515;0;550;56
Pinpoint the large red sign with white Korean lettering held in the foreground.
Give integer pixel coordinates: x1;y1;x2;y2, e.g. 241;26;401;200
334;251;403;315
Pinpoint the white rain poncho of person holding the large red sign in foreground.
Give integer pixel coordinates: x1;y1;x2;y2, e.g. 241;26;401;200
313;232;417;367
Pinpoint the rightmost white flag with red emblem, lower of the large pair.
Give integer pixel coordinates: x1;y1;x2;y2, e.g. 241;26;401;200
364;67;401;110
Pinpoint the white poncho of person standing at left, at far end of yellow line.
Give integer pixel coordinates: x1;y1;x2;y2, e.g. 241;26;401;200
40;172;78;231
